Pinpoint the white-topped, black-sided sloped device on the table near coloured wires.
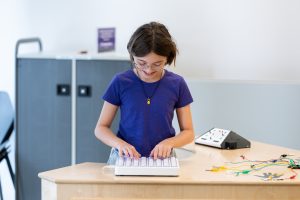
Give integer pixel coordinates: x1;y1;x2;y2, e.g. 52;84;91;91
195;128;251;149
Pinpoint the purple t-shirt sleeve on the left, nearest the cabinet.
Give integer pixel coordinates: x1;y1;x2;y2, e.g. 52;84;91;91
102;75;121;106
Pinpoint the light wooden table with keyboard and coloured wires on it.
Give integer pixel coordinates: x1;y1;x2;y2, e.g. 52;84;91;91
39;141;300;200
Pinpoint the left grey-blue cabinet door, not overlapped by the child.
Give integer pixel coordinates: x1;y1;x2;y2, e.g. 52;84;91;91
16;59;71;200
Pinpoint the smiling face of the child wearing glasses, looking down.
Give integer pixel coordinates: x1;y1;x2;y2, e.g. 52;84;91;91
133;52;167;82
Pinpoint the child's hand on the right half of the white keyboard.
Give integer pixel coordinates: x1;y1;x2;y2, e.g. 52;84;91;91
150;139;173;160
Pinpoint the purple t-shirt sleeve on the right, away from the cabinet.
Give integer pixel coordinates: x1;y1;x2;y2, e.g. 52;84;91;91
175;78;193;108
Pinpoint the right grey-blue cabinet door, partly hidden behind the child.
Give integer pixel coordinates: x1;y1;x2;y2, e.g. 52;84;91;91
76;60;131;163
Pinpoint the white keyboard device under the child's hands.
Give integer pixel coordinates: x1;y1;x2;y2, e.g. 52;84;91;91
115;156;179;176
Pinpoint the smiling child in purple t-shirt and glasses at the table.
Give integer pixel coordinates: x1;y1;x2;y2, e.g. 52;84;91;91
95;22;194;164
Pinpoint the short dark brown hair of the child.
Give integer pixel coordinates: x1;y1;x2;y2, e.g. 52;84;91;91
127;22;178;65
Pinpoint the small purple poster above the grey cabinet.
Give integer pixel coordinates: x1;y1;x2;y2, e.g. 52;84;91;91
98;28;116;52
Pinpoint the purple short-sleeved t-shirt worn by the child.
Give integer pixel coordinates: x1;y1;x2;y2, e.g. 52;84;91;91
103;70;193;156
